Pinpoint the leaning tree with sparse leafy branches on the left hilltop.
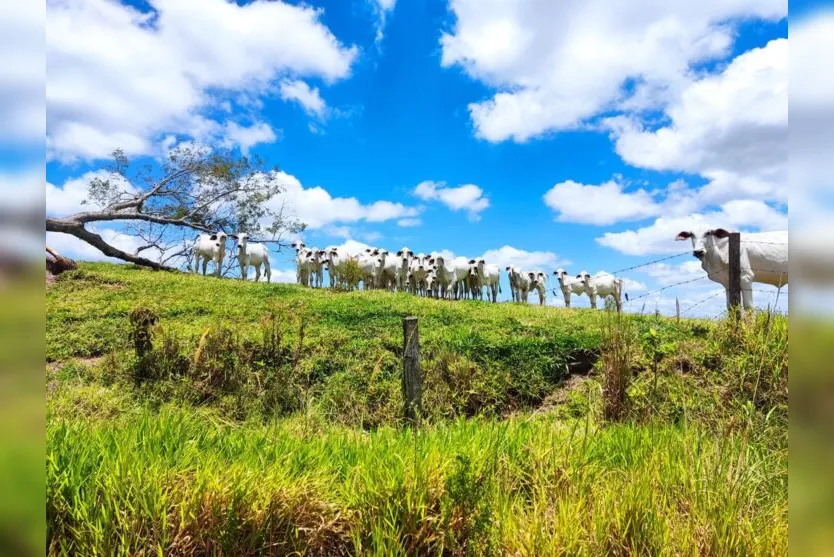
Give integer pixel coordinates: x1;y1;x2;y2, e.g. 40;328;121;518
46;147;304;270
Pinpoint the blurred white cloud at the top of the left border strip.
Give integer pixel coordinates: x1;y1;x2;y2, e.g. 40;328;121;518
0;2;46;144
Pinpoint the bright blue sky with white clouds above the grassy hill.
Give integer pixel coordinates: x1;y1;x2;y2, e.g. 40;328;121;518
30;0;800;315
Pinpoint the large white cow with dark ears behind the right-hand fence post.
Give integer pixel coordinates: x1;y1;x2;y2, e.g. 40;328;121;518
675;228;788;309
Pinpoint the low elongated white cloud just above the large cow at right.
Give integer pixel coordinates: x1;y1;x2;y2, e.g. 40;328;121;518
596;200;788;255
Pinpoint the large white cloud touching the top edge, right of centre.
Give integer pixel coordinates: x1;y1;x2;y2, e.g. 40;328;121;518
440;0;788;142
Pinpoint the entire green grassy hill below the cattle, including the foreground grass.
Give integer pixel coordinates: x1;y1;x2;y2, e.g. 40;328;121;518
46;264;787;555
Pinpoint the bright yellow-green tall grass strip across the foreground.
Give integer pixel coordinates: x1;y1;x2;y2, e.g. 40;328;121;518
47;407;787;555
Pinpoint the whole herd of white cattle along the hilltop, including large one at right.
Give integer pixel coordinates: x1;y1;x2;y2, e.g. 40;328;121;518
194;228;788;311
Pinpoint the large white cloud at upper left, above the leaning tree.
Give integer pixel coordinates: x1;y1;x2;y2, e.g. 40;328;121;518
47;0;358;160
